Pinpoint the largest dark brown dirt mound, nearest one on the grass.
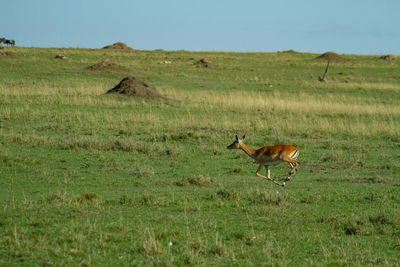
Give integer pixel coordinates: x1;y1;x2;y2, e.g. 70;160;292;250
107;77;161;97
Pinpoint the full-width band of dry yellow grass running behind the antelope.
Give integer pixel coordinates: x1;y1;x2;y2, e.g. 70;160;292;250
0;84;400;139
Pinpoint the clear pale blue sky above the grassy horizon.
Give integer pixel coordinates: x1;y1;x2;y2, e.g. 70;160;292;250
0;0;400;55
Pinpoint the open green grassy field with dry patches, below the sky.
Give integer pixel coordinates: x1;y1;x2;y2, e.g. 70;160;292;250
0;47;400;266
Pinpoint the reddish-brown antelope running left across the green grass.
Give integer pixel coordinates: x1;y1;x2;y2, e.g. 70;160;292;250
228;135;300;186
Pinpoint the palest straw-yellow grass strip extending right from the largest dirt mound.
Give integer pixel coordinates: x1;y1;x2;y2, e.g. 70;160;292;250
166;90;400;115
